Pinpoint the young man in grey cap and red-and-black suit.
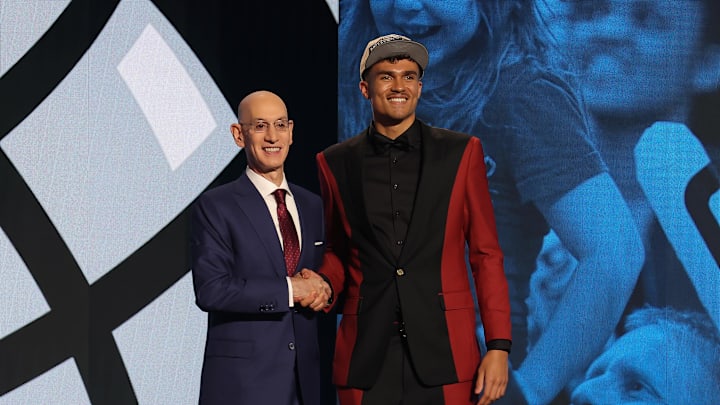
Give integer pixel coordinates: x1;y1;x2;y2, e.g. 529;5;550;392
317;35;511;405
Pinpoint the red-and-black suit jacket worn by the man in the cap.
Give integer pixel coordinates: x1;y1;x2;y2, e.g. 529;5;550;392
317;123;510;389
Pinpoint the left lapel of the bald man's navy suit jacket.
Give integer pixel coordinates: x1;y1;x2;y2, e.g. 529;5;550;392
235;175;287;276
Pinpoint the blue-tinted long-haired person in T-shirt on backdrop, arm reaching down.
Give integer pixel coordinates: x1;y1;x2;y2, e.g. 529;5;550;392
339;0;643;404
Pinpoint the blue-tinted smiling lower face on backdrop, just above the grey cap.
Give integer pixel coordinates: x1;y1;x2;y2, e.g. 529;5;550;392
370;0;480;70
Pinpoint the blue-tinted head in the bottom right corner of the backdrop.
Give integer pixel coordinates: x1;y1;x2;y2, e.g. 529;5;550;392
572;306;720;405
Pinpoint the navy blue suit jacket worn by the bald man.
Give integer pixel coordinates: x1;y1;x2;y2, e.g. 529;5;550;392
191;175;324;405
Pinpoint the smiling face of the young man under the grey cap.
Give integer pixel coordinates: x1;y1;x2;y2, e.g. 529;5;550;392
360;59;422;138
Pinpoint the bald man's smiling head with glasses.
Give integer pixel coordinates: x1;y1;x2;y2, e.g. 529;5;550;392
230;91;293;185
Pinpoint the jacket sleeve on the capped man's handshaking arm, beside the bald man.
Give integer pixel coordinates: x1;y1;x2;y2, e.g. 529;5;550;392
316;153;349;312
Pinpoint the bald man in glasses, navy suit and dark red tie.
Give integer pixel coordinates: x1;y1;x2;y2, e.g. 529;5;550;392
191;91;331;405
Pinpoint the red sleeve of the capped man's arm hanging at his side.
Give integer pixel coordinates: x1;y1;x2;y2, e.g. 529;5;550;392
465;138;511;342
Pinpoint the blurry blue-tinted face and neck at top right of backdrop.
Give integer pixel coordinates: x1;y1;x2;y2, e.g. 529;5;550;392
548;0;720;224
